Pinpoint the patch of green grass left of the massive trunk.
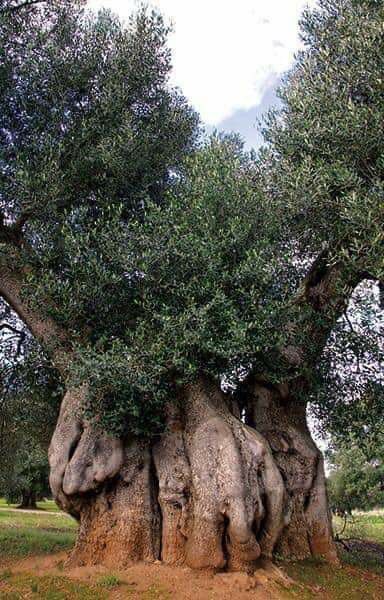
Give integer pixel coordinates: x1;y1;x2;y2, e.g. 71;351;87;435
0;509;77;558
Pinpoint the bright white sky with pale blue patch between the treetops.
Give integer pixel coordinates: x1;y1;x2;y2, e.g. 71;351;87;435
88;0;316;147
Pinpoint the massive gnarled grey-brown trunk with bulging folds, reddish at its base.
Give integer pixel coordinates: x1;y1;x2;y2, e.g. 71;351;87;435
50;379;336;570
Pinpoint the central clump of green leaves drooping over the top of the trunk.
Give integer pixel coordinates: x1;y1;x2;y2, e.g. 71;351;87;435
67;137;292;433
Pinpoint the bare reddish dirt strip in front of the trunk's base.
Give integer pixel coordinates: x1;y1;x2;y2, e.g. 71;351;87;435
3;553;291;600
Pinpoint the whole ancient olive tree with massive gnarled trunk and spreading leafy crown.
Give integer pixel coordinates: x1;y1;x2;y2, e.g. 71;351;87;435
0;0;384;569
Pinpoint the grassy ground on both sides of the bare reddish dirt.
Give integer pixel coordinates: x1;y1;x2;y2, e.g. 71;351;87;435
0;501;384;600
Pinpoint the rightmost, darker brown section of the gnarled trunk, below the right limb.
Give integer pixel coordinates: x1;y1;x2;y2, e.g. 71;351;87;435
248;380;337;561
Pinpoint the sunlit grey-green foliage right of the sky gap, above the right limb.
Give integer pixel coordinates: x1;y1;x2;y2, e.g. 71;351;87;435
265;0;384;279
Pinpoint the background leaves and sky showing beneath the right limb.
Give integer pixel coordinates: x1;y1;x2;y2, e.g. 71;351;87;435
311;282;384;450
